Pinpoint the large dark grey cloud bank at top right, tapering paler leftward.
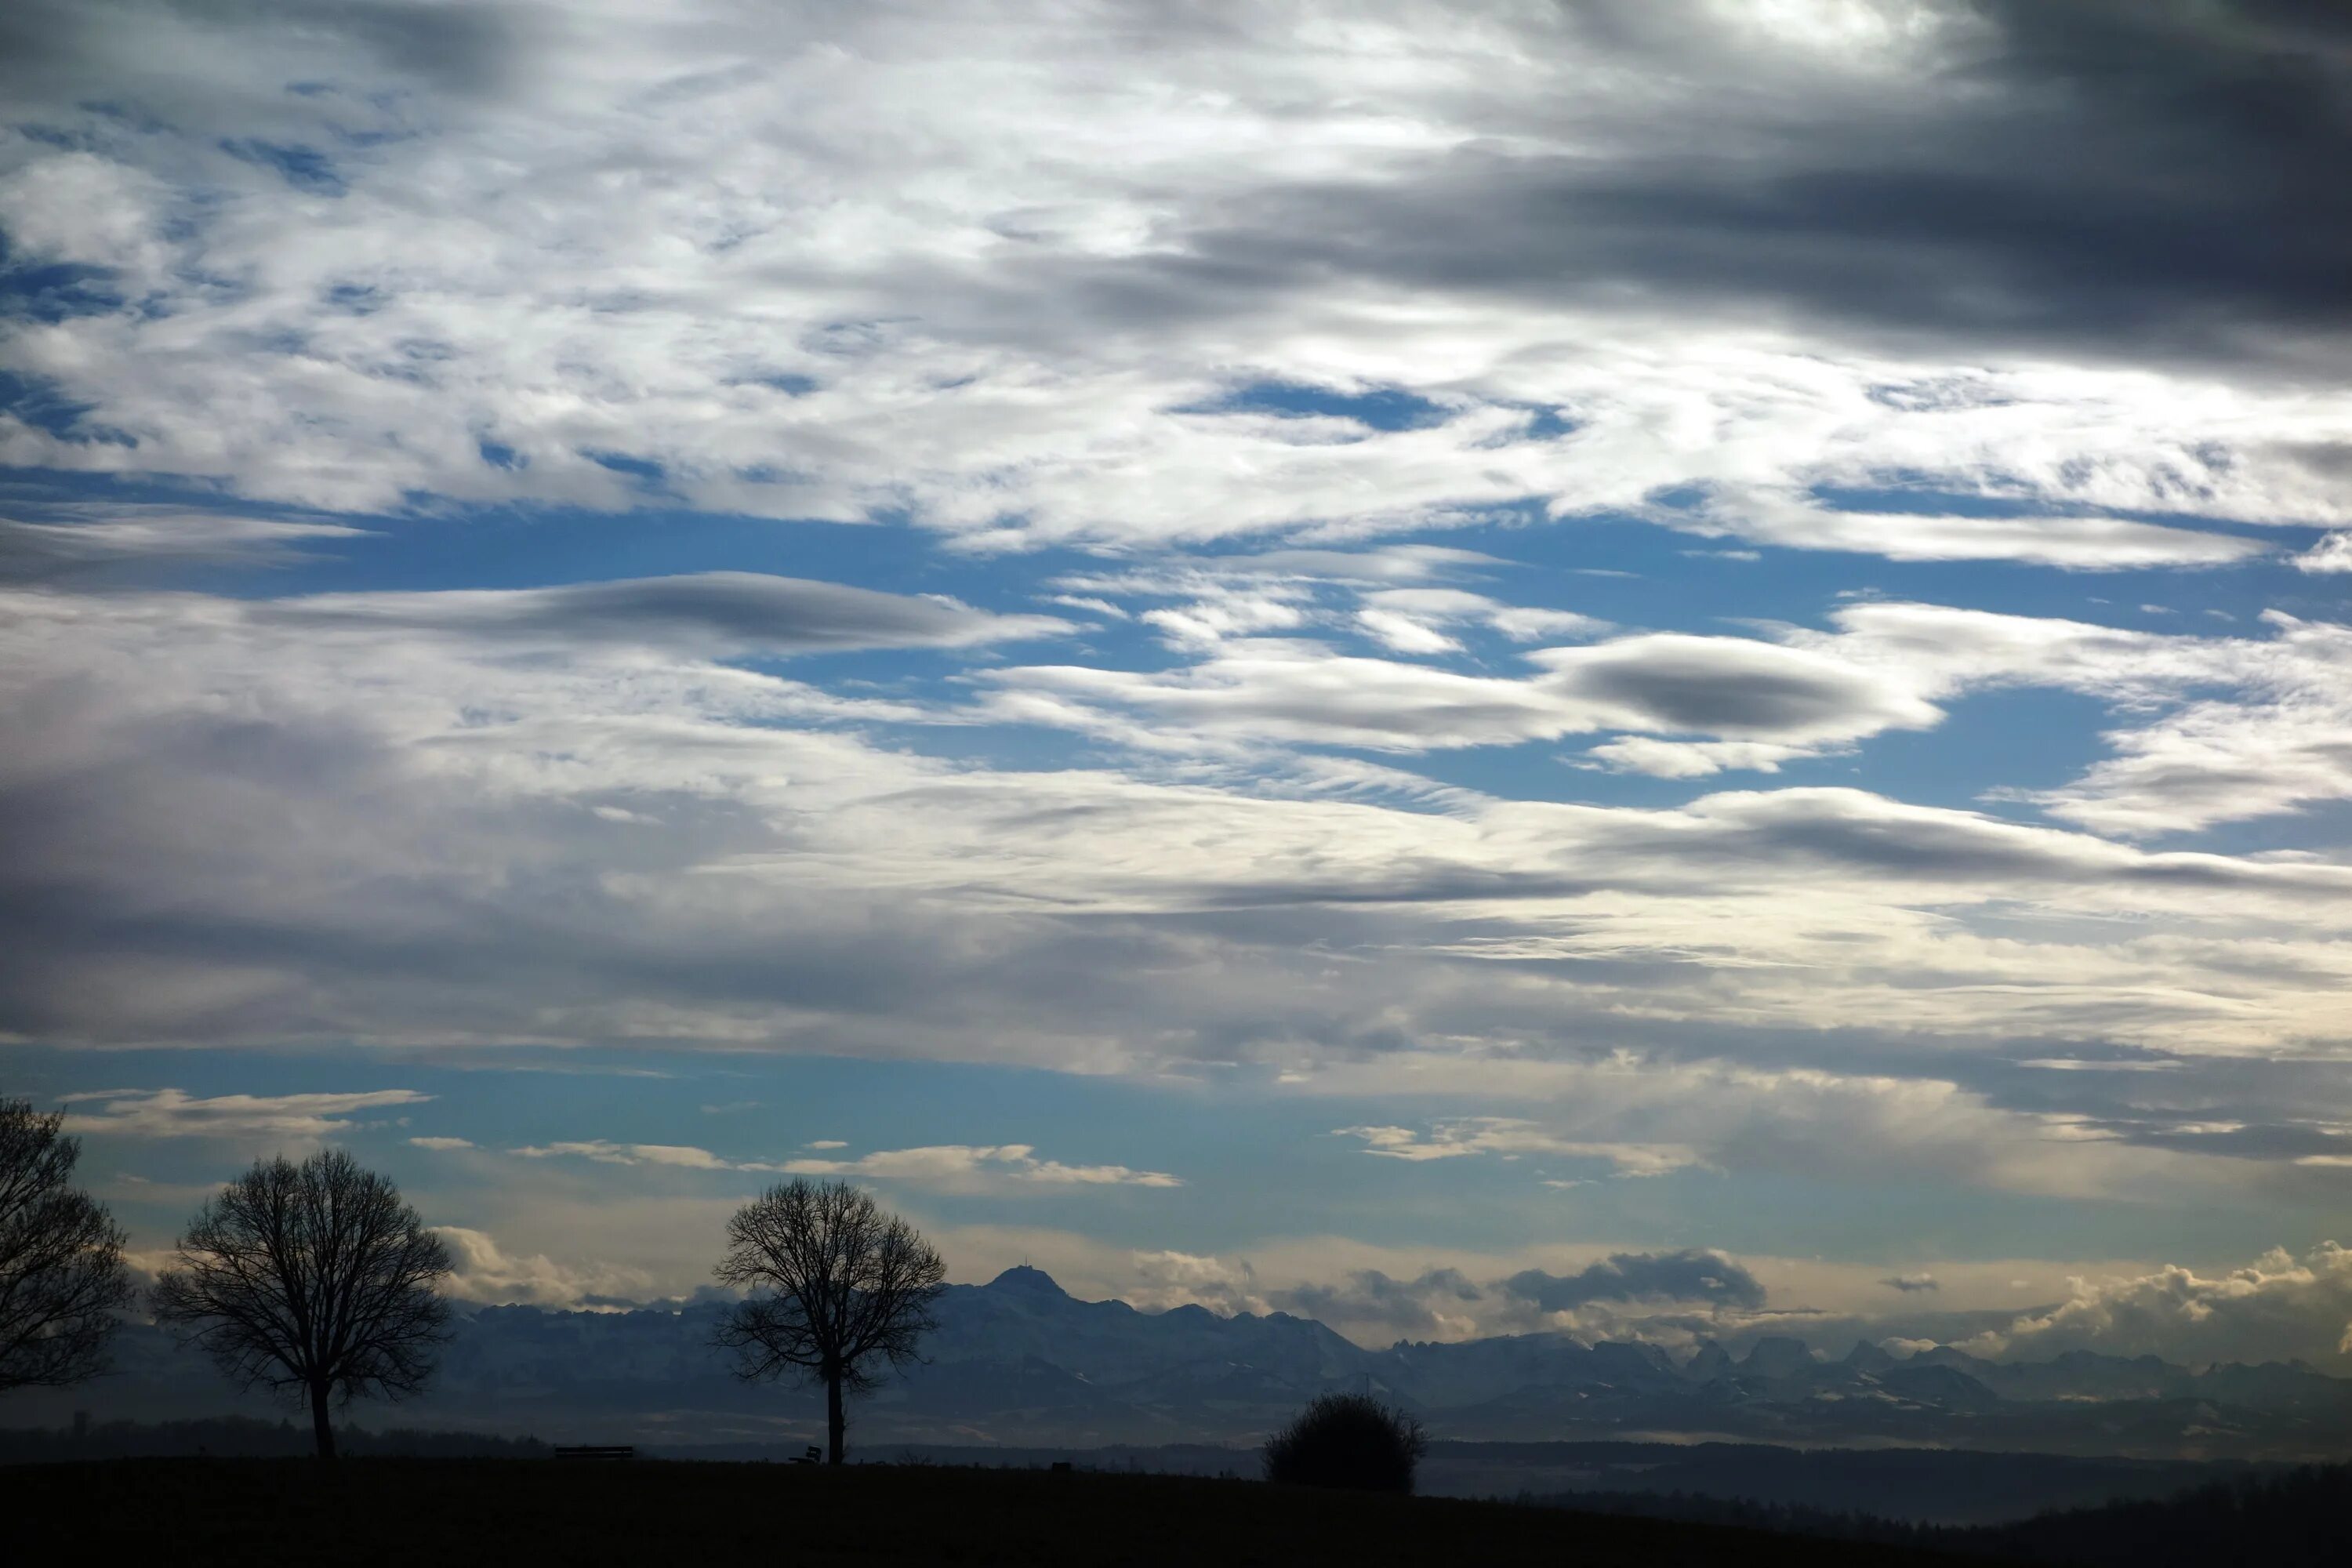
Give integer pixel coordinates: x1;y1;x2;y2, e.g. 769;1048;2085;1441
946;0;2352;372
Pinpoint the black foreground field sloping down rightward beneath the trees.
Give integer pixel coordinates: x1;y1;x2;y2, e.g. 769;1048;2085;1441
0;1460;1962;1568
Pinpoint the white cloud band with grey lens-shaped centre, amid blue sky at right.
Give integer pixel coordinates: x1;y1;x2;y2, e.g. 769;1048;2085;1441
985;590;2352;837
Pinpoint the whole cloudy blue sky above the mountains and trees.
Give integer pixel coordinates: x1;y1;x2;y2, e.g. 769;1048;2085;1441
0;0;2352;1373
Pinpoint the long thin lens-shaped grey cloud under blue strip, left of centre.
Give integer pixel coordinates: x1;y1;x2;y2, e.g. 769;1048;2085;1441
266;572;1068;654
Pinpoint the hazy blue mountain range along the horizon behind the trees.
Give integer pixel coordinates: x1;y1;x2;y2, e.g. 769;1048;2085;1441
18;1267;2352;1490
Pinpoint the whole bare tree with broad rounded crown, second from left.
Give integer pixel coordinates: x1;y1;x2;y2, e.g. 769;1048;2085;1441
155;1149;449;1460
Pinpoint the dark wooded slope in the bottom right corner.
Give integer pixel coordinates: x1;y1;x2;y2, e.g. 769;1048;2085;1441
1522;1465;2352;1568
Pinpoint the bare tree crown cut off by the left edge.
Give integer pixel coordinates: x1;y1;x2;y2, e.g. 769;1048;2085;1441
0;1100;132;1394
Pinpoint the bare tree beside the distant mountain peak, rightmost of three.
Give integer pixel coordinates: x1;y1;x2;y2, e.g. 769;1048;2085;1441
713;1180;948;1465
